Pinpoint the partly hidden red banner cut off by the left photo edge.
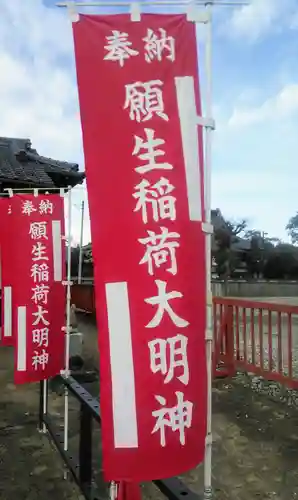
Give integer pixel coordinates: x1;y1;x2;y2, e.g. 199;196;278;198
0;198;14;346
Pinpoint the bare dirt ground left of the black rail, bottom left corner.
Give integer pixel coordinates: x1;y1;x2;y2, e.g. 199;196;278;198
0;347;82;500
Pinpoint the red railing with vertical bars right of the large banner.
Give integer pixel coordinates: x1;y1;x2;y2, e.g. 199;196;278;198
213;297;298;389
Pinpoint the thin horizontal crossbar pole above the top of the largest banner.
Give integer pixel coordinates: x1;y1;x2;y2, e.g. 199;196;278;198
56;0;249;7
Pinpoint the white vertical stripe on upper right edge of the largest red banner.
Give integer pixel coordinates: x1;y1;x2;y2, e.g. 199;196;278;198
175;76;202;221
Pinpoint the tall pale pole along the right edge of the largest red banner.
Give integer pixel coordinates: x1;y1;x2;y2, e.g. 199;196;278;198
204;3;213;500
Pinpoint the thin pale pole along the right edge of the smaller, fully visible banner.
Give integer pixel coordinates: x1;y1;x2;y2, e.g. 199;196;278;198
64;186;72;458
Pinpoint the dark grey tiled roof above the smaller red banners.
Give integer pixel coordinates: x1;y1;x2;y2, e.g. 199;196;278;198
0;137;85;188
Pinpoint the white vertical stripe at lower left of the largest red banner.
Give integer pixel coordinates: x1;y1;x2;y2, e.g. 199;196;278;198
106;282;138;448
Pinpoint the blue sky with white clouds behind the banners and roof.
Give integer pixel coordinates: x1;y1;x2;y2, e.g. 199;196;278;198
0;0;298;243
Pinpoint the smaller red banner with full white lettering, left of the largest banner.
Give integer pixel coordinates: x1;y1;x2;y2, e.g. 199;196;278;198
11;194;66;384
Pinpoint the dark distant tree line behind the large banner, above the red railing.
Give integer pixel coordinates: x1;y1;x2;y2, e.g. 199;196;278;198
71;212;298;280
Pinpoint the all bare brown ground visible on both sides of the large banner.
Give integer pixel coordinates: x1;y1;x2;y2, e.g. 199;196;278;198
0;318;298;500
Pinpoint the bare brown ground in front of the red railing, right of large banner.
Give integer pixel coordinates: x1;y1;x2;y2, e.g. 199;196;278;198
204;378;298;500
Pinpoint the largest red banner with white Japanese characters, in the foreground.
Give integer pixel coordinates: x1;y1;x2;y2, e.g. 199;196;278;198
73;14;207;481
